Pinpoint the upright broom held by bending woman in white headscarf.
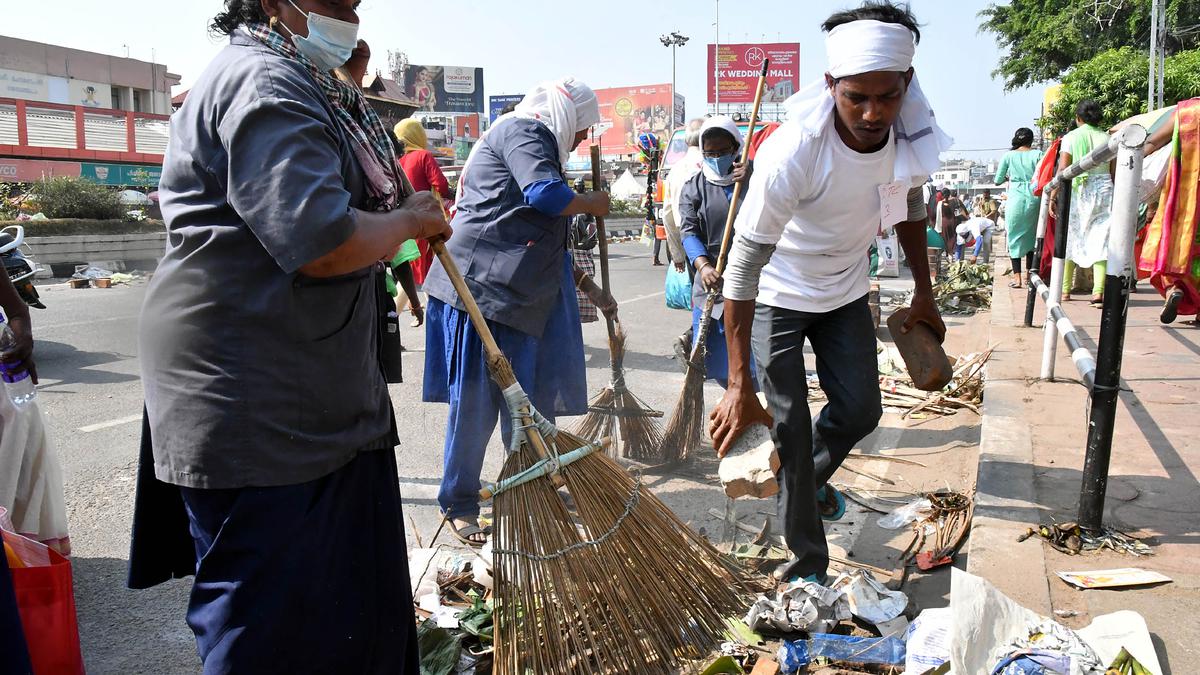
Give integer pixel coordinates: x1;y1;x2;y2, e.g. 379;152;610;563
575;145;662;461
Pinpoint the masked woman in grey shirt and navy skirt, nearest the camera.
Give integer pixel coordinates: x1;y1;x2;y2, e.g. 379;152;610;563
128;0;450;674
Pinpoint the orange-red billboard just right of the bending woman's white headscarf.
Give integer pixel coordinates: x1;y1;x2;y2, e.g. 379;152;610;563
576;84;685;157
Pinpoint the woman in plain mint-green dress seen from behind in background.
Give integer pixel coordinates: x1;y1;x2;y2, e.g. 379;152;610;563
996;126;1042;288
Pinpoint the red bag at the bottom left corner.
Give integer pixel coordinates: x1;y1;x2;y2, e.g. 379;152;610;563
2;532;84;675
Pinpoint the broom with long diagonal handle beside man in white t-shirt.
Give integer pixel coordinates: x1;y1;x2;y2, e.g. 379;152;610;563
659;60;770;464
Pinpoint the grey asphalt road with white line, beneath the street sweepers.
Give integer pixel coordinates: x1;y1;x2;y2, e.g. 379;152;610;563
35;244;985;674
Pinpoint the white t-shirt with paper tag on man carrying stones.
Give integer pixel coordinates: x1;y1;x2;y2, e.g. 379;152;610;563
734;117;895;312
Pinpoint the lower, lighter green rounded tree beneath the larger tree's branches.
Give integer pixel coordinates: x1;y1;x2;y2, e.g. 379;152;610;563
1042;47;1200;136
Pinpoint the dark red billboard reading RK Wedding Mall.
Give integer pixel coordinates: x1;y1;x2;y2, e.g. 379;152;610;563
708;42;800;103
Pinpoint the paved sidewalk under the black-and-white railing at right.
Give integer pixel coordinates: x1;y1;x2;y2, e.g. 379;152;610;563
968;261;1200;673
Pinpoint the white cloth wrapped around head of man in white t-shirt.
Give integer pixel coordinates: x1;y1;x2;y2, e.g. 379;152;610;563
784;19;954;187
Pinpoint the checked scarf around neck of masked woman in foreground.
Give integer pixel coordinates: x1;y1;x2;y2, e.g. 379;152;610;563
244;22;406;211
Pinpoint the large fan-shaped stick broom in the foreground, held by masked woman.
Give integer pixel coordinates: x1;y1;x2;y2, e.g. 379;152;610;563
432;241;750;675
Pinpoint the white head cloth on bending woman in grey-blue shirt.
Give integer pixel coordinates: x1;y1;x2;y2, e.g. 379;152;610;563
457;77;600;197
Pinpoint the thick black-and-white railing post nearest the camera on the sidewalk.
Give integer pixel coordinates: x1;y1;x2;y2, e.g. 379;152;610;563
1080;125;1147;532
